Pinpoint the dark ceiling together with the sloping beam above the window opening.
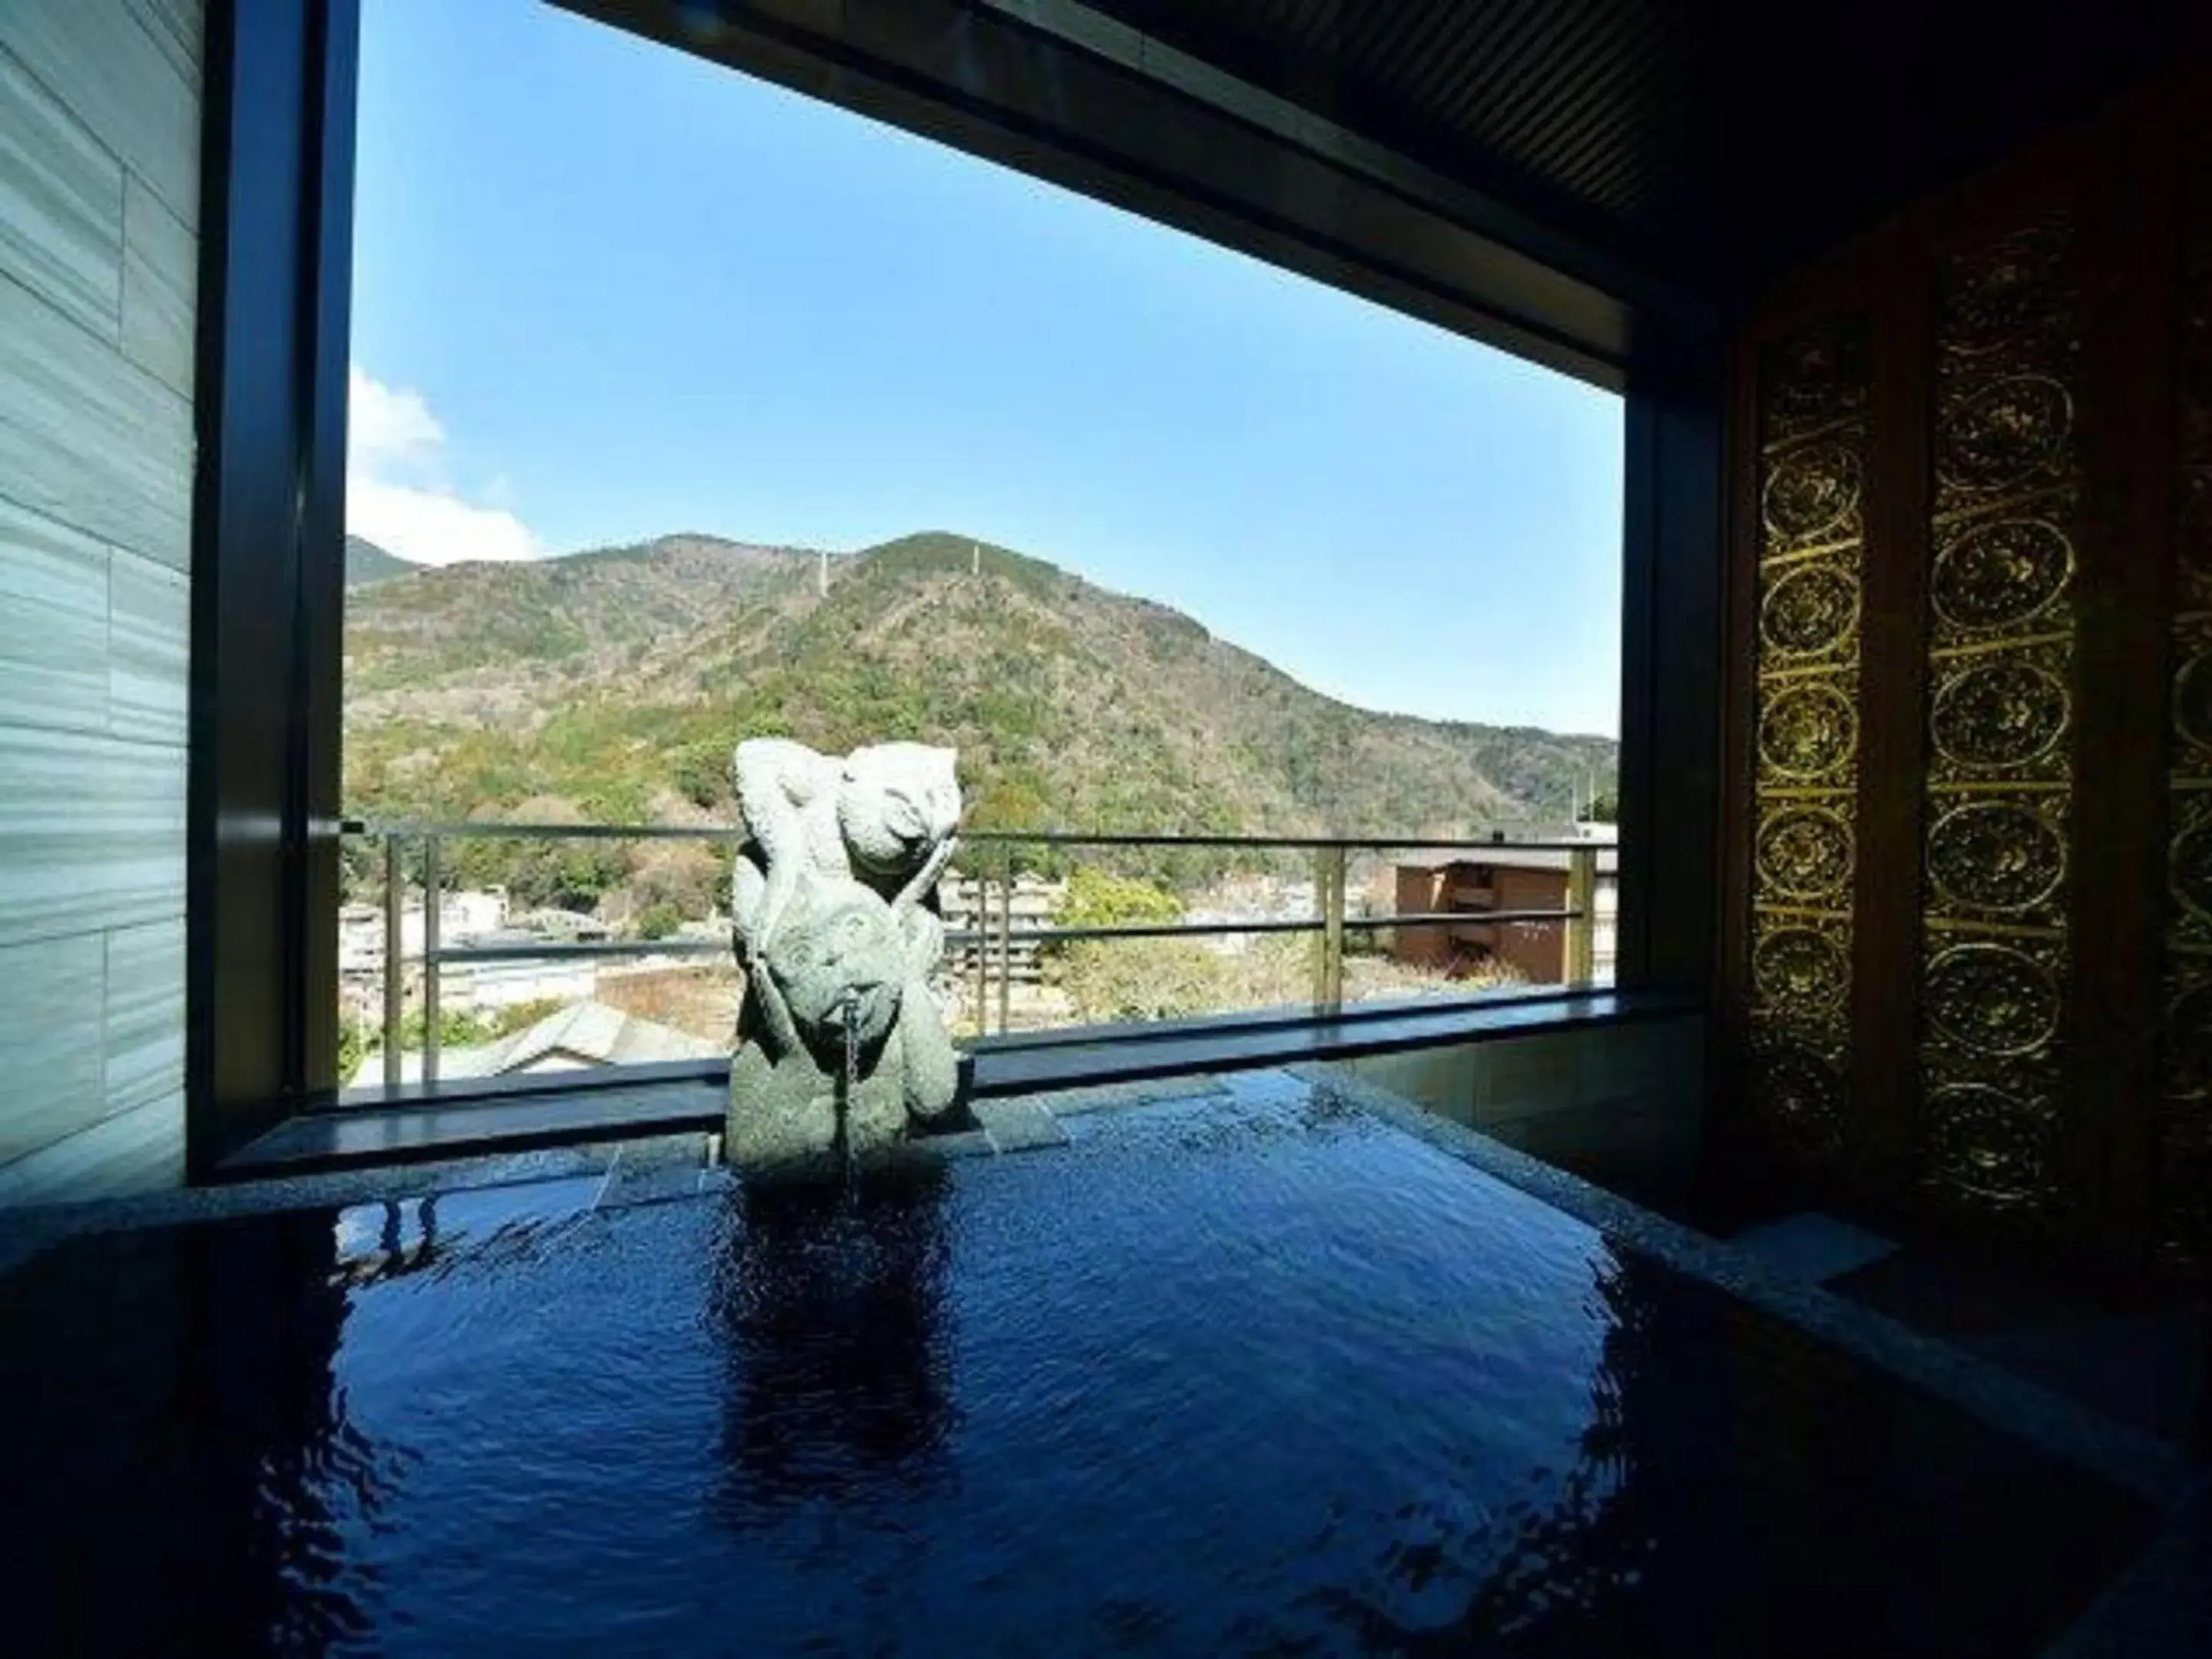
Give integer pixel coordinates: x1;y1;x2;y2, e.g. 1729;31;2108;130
553;0;2212;376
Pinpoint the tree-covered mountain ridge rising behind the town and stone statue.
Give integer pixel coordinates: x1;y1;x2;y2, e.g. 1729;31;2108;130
345;533;1614;871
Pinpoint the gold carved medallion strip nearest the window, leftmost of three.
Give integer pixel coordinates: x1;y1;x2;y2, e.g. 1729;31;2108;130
1750;319;1867;1161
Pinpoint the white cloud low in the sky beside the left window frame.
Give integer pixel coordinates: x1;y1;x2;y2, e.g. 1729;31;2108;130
345;365;544;564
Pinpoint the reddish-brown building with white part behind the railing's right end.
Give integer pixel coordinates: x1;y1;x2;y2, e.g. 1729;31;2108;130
1376;825;1619;985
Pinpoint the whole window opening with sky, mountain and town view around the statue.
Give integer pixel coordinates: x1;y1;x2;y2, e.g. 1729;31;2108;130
339;0;1624;1088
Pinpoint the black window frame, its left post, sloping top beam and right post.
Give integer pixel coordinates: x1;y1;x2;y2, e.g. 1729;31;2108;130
186;0;1725;1179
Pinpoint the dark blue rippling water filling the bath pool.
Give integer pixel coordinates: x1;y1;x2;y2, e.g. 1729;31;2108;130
0;1078;2144;1659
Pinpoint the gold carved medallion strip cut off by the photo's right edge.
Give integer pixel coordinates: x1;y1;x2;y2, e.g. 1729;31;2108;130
2159;137;2212;1270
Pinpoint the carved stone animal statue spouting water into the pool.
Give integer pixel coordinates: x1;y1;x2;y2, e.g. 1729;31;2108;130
724;737;960;1172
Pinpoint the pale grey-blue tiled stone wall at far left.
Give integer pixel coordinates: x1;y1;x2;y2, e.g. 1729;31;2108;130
0;0;201;1204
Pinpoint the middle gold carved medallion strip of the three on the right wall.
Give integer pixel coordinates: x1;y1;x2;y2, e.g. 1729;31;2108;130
1920;214;2081;1219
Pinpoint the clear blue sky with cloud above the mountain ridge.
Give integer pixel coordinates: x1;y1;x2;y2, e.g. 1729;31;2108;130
349;0;1621;734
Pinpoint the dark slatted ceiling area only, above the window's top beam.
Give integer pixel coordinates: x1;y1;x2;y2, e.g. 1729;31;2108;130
1091;0;2212;296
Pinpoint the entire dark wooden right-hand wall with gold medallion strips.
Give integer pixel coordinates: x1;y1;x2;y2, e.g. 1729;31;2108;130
1721;58;2212;1267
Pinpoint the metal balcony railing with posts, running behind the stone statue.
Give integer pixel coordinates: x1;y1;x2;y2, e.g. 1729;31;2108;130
343;819;1608;1088
